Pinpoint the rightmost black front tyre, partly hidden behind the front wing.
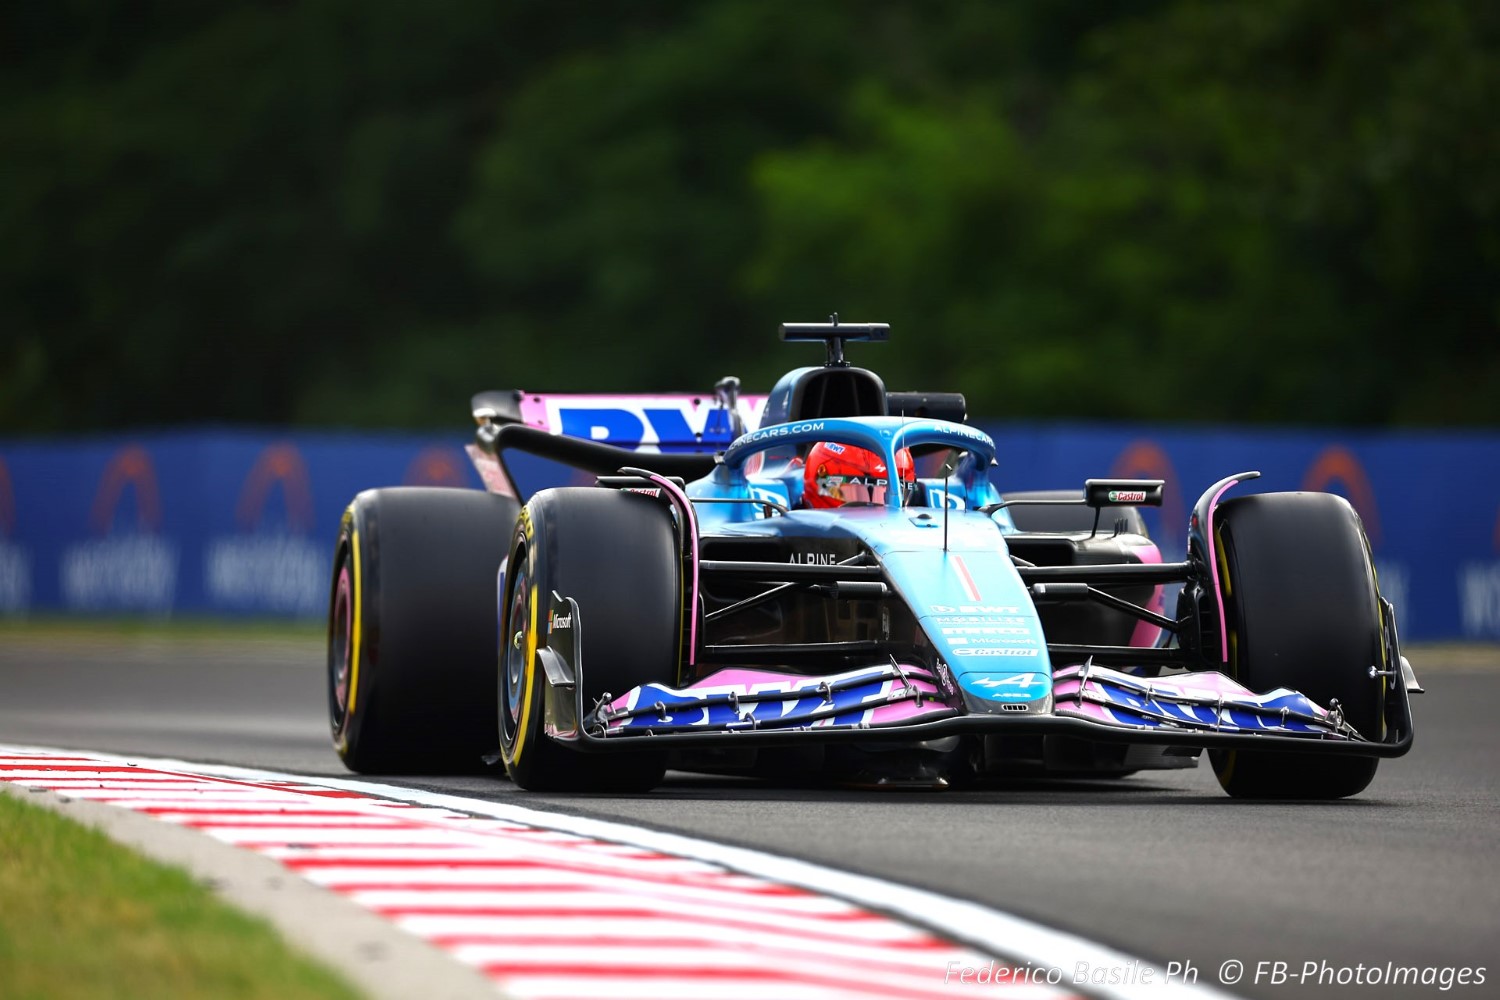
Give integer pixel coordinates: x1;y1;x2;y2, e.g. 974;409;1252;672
1209;493;1386;799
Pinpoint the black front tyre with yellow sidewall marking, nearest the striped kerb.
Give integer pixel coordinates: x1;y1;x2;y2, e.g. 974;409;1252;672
500;487;683;792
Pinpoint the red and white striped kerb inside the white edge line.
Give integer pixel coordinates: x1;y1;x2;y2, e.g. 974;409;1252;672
0;749;1076;1000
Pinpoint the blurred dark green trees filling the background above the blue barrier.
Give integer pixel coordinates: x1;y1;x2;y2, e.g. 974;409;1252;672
0;0;1500;433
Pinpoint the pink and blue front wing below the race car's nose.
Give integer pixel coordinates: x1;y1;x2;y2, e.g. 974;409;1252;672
566;658;1410;757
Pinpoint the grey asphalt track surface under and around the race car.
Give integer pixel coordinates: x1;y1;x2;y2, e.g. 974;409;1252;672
0;633;1500;999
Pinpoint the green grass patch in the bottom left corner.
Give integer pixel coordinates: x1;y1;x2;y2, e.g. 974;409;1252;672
0;795;360;1000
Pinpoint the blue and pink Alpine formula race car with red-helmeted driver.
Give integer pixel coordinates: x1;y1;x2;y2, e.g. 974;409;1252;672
329;325;1421;799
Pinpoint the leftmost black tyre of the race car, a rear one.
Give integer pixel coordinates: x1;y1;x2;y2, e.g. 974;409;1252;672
329;487;519;774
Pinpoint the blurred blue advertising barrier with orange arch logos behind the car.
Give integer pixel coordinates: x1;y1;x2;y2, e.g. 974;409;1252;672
0;423;1500;640
